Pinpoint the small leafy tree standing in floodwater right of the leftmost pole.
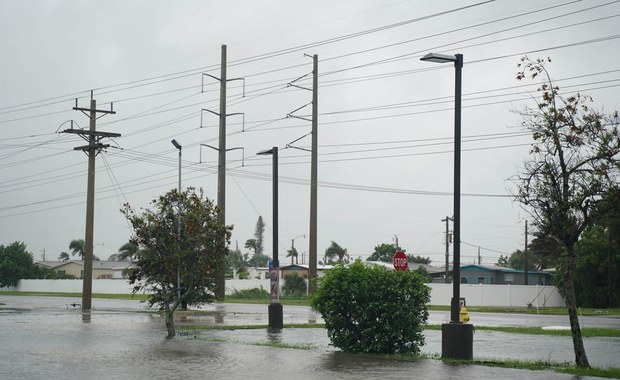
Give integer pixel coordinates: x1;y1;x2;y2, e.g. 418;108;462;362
121;188;232;338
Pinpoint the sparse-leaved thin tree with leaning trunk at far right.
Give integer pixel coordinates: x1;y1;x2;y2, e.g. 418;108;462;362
516;57;620;367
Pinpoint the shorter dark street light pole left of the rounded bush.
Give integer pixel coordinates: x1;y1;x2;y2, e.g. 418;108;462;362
257;146;283;329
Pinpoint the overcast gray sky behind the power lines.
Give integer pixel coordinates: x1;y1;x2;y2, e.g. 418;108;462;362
0;0;620;265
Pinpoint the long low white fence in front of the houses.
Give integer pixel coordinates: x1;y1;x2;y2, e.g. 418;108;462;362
0;279;565;307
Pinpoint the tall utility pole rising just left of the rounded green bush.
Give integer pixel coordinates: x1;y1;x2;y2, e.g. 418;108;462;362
308;54;319;294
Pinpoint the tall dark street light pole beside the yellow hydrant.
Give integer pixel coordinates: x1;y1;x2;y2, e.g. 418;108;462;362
421;53;473;359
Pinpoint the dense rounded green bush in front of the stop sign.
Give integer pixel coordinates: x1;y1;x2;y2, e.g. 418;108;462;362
310;260;430;354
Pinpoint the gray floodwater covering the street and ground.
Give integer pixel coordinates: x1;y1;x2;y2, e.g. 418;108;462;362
0;295;620;380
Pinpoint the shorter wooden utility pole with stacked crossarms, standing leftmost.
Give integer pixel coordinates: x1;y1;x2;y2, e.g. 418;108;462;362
62;92;121;310
